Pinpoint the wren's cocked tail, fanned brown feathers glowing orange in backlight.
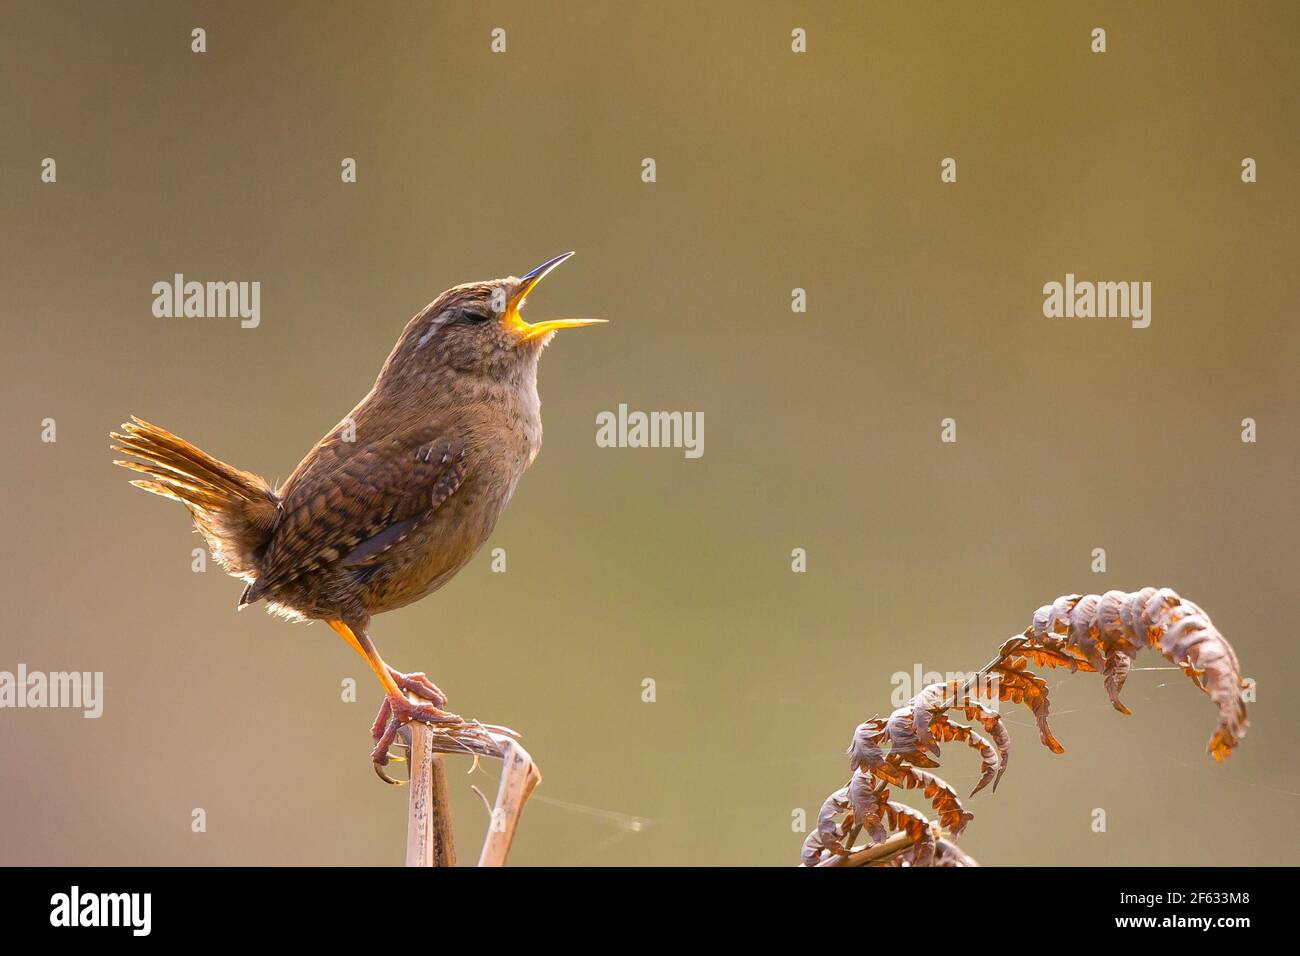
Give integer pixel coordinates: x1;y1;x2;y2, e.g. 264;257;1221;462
111;416;281;581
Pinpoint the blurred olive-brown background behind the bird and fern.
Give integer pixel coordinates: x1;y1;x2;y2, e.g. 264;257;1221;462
0;0;1300;865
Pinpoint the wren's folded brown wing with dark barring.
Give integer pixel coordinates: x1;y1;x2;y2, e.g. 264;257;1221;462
243;425;465;604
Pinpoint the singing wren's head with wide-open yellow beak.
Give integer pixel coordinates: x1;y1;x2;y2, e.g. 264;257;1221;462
389;252;605;380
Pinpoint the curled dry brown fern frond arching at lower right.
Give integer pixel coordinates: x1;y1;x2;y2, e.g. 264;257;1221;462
802;588;1248;866
